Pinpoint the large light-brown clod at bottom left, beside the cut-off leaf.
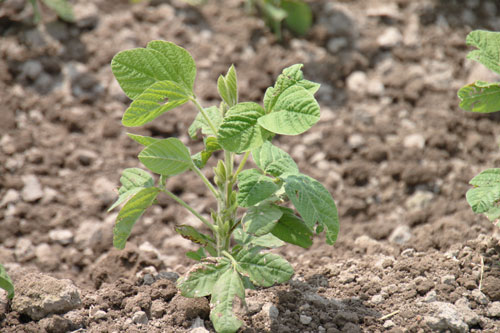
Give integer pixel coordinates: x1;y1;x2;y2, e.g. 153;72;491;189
12;273;82;320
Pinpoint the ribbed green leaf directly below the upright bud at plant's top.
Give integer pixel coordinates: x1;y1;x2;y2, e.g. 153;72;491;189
217;102;269;153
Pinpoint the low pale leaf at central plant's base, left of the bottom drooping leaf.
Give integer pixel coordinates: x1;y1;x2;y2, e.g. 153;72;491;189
177;258;229;297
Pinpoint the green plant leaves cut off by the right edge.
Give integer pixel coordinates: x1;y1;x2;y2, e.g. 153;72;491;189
458;30;500;227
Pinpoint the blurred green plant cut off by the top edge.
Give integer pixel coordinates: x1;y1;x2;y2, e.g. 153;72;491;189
246;0;312;40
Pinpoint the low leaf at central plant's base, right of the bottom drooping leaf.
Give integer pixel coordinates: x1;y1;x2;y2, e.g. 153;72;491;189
235;248;293;287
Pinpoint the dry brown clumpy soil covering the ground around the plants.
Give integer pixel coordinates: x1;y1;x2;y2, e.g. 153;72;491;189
0;0;500;333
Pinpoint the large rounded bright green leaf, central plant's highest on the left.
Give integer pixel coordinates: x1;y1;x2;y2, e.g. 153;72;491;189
111;41;196;99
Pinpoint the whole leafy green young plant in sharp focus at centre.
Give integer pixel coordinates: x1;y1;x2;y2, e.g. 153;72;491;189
110;41;339;332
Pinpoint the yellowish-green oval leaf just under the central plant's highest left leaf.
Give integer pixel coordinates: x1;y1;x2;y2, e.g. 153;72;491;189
122;81;189;127
